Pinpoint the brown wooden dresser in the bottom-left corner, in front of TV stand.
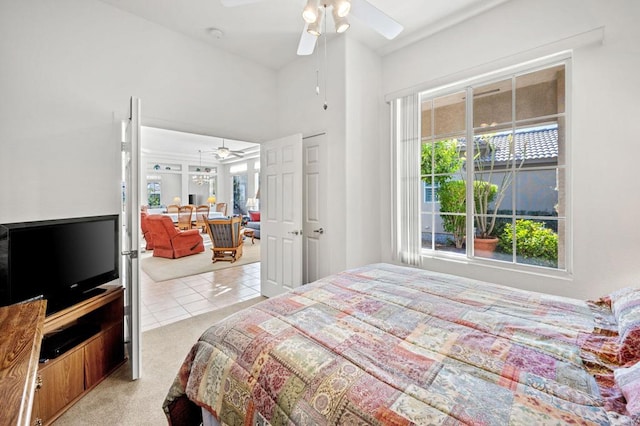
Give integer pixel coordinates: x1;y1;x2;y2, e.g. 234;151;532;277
0;300;47;426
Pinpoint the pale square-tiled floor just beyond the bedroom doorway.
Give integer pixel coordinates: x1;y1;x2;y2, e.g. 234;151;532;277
140;262;260;332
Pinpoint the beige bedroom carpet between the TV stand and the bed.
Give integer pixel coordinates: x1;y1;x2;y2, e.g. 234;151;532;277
55;297;266;426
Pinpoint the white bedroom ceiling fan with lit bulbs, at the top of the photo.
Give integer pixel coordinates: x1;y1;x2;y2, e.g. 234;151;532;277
221;0;403;55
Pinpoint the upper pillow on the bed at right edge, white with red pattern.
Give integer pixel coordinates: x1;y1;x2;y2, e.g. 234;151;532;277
609;288;640;364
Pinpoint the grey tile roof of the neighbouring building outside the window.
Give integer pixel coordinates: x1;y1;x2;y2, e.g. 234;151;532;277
458;125;558;163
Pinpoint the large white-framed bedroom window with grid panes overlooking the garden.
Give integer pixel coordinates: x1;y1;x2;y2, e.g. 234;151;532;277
416;62;567;270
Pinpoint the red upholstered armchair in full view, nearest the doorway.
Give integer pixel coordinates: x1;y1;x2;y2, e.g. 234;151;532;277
147;214;204;259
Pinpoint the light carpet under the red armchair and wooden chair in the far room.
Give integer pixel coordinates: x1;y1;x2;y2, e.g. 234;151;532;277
140;238;260;282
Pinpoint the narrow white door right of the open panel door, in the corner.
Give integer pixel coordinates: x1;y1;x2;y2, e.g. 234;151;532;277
302;134;331;284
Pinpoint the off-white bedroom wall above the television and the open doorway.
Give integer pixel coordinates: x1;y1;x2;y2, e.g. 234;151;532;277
0;0;276;223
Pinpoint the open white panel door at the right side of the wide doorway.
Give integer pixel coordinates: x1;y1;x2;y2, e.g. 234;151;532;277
260;134;302;297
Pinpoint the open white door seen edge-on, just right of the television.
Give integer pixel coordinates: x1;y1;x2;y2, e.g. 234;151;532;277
120;97;142;380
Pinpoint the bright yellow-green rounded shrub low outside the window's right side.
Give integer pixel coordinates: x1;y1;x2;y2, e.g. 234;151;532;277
498;219;558;267
